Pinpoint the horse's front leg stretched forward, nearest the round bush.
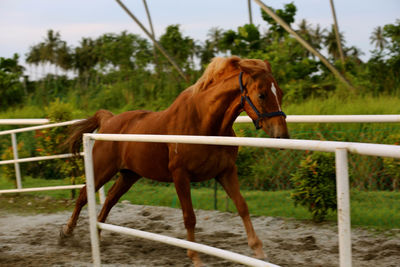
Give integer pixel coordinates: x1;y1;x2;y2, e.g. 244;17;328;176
217;165;265;259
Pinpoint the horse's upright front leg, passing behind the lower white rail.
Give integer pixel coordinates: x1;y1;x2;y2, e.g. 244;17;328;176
172;169;203;267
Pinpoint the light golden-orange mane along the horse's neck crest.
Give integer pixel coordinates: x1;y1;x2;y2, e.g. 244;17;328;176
188;56;270;94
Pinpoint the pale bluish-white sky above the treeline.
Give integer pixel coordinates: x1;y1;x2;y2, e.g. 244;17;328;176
0;0;400;74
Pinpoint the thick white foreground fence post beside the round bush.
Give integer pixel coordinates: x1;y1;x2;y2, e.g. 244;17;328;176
335;148;352;267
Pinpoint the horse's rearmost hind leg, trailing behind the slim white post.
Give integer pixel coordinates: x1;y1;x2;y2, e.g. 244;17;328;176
60;161;117;238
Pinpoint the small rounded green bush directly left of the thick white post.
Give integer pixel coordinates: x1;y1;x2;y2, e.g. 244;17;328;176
291;152;337;222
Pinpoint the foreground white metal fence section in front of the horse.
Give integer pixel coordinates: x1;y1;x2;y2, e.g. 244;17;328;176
83;134;400;267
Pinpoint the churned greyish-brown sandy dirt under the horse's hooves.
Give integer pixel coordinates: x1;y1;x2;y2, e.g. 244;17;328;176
0;203;400;267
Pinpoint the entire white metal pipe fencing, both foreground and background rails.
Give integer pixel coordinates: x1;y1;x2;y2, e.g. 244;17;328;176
0;115;400;267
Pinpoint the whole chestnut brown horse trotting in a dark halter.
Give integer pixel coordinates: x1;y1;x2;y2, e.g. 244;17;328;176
61;57;289;266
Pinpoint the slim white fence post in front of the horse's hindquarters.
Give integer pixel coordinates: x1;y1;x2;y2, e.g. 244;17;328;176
83;134;101;267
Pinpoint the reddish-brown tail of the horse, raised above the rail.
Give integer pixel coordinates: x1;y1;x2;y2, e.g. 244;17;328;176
64;109;114;155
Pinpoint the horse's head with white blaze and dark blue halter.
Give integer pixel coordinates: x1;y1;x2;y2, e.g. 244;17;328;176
238;59;289;138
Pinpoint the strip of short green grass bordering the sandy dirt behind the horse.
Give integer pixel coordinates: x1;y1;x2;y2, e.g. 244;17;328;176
0;178;400;230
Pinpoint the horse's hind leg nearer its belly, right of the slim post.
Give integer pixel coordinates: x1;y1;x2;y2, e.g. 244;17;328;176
98;170;140;225
